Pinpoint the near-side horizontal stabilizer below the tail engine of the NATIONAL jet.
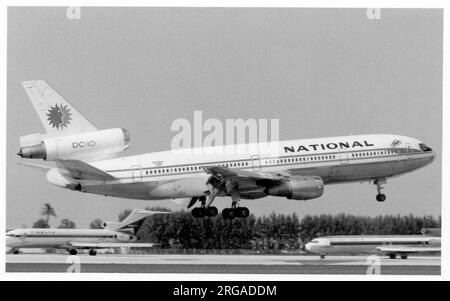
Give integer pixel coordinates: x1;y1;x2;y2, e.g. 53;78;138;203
58;160;116;181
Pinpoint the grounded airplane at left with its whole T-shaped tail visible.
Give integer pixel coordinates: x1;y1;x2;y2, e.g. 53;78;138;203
6;209;169;256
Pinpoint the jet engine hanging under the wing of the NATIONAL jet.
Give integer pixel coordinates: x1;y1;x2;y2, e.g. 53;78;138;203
266;176;324;200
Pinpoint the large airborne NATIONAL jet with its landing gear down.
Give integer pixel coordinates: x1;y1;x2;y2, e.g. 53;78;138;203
18;80;435;219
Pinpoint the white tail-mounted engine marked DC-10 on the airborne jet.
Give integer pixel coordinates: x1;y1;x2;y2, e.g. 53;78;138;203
18;128;130;162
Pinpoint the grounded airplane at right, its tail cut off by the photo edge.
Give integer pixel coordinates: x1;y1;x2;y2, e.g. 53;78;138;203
305;229;441;259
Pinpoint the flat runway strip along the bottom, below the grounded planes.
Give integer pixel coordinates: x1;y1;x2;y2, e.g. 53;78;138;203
6;254;441;275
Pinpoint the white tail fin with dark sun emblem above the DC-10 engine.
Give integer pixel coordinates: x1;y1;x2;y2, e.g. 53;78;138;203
22;80;97;135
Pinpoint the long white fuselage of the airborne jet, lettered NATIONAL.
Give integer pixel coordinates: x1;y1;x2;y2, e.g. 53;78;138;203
48;135;435;200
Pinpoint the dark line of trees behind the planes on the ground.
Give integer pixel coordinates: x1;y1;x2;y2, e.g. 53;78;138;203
33;203;441;251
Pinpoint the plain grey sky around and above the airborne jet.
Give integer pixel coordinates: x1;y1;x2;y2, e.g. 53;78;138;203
5;7;443;228
